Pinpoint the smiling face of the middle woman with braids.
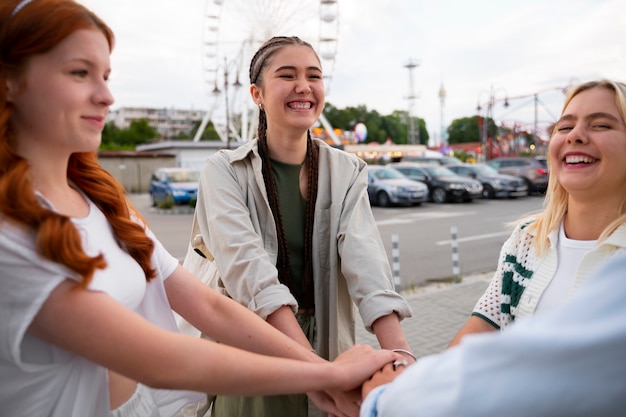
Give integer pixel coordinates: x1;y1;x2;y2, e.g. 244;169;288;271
250;45;324;136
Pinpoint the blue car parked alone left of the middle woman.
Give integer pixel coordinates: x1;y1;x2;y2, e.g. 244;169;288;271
150;168;200;206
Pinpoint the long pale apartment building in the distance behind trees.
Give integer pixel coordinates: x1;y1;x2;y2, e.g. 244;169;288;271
107;107;205;138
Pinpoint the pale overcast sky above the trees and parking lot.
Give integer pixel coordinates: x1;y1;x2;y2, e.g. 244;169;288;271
79;0;626;145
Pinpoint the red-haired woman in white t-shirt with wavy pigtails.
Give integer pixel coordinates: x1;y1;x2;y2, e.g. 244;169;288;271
0;0;400;417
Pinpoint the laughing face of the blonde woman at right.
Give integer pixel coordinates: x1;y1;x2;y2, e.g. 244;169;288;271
549;87;626;199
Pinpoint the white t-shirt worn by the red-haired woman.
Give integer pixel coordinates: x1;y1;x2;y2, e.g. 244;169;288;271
0;197;204;417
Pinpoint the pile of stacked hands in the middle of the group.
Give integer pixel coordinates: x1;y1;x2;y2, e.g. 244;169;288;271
307;345;416;417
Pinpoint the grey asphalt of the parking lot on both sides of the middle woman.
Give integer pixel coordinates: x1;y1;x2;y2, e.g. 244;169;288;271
130;194;543;288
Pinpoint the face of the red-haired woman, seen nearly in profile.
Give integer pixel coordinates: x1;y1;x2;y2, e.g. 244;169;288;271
7;29;113;160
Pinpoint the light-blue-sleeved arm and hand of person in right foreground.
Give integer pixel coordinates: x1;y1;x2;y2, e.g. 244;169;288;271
360;251;626;417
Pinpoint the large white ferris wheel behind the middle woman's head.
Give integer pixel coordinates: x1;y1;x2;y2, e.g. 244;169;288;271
193;0;339;143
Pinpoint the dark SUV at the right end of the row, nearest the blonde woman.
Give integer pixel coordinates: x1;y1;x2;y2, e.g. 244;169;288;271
487;156;548;194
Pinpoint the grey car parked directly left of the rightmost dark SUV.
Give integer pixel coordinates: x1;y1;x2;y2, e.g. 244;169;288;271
448;164;528;198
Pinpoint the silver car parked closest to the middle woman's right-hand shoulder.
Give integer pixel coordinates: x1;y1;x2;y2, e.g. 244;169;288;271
367;165;428;207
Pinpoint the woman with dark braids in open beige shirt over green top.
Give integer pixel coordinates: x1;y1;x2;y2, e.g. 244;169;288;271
179;37;413;417
